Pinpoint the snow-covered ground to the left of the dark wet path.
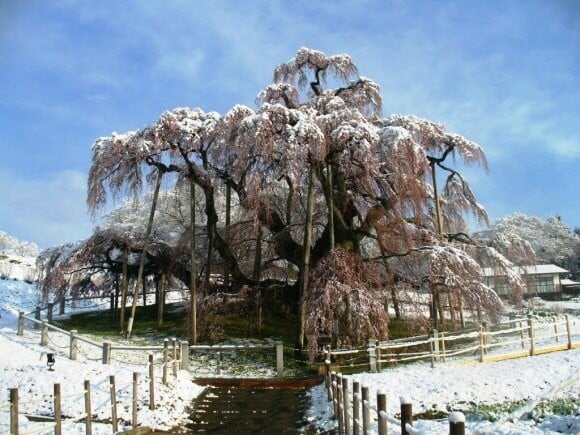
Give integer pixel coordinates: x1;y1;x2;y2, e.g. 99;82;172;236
0;280;203;434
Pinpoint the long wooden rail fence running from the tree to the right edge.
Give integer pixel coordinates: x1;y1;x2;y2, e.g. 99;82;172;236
325;315;580;372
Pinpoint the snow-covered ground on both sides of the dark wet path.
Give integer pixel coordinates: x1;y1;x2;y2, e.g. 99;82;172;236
0;274;580;435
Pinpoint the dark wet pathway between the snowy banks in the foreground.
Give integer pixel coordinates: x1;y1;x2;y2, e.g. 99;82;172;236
187;387;324;434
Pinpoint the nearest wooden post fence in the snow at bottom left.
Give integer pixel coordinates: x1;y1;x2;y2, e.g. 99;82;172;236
0;372;147;435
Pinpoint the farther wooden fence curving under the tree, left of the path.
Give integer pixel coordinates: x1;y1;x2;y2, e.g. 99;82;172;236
17;311;284;381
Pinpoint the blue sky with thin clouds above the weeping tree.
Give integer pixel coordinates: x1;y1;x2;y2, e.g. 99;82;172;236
0;0;580;248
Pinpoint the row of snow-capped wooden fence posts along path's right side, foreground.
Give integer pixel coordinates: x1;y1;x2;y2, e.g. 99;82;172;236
325;372;465;435
